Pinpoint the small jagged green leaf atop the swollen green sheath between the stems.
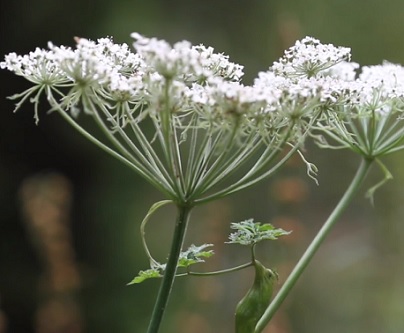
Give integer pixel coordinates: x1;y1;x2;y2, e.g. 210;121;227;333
227;219;291;245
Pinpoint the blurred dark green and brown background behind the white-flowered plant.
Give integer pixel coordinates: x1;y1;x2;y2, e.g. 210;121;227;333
0;0;404;333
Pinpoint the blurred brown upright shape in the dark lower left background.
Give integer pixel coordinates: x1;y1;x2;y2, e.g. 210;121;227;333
20;173;83;333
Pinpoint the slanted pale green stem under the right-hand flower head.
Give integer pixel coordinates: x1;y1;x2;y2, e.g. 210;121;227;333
255;158;373;333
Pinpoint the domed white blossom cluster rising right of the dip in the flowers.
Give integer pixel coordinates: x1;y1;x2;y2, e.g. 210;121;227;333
254;37;358;118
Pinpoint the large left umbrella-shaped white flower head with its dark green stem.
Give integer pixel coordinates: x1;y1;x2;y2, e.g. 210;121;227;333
0;33;320;332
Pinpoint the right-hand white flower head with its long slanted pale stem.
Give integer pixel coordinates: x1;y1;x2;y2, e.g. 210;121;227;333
253;38;404;333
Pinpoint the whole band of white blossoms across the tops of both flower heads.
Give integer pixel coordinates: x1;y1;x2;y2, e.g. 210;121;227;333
0;33;404;136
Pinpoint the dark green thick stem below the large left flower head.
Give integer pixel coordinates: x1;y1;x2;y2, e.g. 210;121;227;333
147;205;192;333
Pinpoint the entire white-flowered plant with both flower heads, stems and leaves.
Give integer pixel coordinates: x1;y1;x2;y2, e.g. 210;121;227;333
0;33;403;333
